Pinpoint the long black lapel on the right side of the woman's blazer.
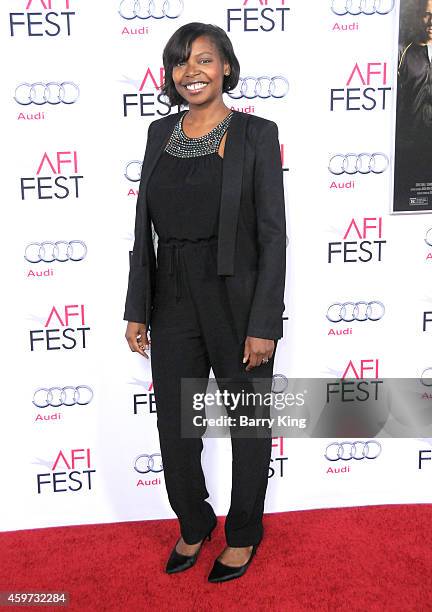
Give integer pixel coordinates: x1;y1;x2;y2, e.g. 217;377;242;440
217;111;248;276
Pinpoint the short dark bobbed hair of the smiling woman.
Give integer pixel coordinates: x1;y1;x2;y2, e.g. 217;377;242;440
161;21;240;106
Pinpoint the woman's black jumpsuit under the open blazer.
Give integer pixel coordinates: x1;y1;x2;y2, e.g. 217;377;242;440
147;115;273;546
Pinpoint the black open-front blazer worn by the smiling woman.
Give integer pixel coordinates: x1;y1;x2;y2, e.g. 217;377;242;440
123;111;286;340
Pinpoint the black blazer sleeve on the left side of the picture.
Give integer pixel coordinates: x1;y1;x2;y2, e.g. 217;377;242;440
123;122;155;323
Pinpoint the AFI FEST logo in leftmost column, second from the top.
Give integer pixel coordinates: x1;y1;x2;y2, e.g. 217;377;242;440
20;151;84;201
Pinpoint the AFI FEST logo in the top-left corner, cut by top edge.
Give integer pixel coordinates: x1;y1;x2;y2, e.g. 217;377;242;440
9;0;77;38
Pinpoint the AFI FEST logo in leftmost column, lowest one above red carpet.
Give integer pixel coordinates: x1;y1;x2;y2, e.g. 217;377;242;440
36;448;96;495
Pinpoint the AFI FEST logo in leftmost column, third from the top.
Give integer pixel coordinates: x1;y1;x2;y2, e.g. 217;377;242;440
29;304;90;351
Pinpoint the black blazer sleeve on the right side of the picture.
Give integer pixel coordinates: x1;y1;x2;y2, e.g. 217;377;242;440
247;121;286;340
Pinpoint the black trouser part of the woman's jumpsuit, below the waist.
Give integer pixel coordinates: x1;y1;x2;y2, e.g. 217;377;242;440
150;239;277;547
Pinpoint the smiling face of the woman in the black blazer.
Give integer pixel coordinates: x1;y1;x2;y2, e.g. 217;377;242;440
172;36;230;105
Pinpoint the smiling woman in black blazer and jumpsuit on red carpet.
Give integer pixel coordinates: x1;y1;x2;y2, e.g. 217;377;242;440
124;23;286;582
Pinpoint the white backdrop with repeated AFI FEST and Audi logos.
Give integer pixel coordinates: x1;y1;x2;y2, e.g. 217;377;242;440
0;0;432;530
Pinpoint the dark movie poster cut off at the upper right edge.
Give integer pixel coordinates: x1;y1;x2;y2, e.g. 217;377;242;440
393;0;432;213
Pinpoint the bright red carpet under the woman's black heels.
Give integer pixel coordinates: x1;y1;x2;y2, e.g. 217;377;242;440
0;504;432;612
